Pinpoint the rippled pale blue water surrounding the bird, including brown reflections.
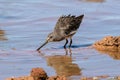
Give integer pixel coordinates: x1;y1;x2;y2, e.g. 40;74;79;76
0;0;120;80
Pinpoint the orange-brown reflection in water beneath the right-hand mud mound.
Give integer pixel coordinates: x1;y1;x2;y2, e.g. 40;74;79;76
98;50;120;60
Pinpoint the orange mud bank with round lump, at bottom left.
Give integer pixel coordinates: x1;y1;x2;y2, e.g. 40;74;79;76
6;68;67;80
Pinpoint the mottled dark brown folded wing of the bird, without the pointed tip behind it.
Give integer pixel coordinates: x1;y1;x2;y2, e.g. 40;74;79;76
54;15;81;36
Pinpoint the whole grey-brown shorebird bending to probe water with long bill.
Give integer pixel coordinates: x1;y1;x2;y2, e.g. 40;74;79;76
37;15;84;51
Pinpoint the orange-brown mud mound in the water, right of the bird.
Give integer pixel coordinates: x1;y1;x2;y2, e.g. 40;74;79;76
93;36;120;52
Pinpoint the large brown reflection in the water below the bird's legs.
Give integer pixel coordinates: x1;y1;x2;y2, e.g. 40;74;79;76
47;55;81;76
